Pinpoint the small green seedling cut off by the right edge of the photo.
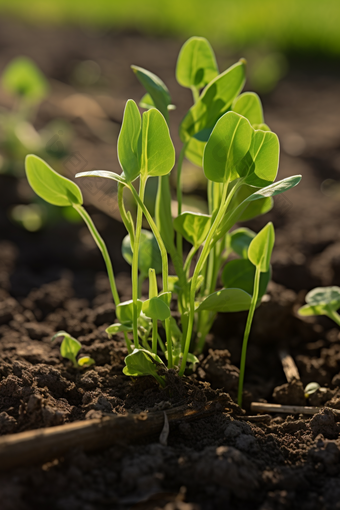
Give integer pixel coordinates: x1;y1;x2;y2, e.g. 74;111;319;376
298;287;340;326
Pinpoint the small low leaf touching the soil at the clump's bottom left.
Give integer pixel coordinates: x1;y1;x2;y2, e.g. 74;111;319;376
123;349;165;387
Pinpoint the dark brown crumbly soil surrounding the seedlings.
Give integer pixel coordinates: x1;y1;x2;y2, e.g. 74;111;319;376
0;17;340;510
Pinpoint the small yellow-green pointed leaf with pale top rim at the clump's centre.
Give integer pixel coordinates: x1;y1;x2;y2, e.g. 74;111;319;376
174;212;211;248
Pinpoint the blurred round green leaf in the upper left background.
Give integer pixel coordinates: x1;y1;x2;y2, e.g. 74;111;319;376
1;57;49;103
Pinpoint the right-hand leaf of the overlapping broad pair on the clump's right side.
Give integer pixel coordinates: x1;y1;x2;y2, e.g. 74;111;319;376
237;131;280;188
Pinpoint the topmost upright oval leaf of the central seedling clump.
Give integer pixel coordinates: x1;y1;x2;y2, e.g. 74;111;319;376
176;37;218;89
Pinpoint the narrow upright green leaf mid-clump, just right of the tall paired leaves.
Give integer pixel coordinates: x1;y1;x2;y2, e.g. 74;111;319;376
155;175;175;253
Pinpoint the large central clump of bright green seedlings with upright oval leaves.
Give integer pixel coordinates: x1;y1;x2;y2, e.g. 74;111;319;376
26;37;301;404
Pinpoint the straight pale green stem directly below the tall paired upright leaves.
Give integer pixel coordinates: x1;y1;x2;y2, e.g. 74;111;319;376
131;175;146;349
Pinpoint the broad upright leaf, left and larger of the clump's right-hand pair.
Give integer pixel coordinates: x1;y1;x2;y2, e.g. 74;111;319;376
203;112;254;182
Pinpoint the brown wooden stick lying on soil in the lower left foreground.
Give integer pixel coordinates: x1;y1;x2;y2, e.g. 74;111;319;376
0;398;230;470
